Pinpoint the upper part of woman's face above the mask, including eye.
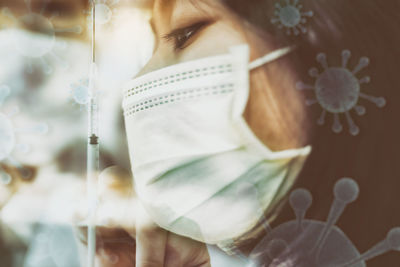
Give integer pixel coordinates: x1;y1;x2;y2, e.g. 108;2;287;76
140;0;246;74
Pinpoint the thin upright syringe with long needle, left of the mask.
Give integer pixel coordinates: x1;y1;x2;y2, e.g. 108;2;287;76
87;0;100;267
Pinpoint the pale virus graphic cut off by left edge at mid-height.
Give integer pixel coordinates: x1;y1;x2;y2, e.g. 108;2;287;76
0;87;48;183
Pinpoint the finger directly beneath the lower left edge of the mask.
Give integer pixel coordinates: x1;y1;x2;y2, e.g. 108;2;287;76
136;205;167;267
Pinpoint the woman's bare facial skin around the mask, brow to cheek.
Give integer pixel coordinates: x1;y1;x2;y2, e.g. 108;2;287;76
139;0;307;150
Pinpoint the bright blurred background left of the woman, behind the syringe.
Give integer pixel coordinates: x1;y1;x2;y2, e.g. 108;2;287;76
0;0;153;267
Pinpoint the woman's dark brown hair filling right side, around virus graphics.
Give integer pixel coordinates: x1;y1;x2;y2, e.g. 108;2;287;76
224;0;400;266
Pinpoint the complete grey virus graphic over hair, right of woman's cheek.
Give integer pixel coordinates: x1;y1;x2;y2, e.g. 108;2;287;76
296;50;386;135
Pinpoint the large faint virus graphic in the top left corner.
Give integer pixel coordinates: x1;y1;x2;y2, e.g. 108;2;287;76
2;0;82;74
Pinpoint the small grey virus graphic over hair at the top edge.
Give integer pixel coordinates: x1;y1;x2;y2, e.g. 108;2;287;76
271;0;313;35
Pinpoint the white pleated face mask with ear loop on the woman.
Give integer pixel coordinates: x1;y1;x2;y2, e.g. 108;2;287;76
123;45;310;247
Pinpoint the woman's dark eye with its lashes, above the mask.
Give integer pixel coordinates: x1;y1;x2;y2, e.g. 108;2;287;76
164;21;210;50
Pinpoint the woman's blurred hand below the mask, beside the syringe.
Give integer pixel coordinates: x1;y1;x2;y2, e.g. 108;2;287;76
76;167;211;267
